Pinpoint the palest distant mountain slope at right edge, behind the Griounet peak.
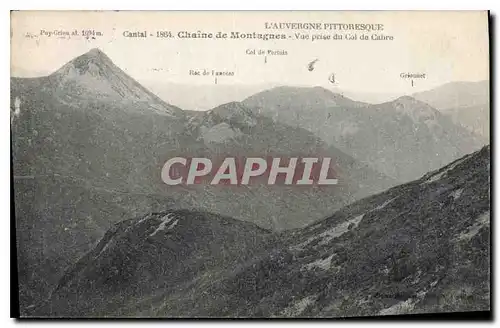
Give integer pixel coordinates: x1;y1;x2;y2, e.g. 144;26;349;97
413;81;490;140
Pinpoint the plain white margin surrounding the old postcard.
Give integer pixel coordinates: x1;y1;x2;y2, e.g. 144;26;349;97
0;0;500;327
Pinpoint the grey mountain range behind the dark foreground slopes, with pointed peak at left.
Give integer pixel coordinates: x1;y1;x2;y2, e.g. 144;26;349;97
11;49;488;314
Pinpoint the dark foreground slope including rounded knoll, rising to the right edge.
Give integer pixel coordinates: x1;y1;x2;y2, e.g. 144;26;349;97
39;146;490;317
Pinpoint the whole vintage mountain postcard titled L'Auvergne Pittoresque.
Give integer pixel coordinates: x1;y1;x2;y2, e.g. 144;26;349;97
10;11;490;318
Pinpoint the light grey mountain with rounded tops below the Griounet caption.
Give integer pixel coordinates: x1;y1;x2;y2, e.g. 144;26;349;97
243;87;482;182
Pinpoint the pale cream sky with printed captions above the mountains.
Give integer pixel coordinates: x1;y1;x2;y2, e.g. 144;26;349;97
12;12;489;93
